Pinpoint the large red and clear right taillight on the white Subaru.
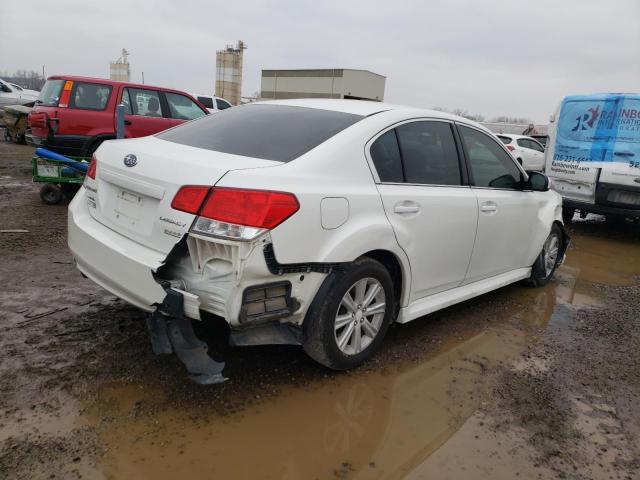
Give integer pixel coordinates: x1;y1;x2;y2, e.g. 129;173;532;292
179;187;300;240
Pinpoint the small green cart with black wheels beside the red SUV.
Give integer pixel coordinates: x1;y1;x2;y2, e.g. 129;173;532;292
31;155;89;205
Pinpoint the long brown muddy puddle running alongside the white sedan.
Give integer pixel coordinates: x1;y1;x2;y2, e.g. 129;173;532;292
69;228;640;479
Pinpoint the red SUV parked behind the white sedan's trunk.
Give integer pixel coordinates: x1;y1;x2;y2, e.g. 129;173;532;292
26;76;208;157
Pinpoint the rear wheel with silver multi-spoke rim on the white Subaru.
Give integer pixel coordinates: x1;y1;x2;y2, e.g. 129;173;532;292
303;257;395;370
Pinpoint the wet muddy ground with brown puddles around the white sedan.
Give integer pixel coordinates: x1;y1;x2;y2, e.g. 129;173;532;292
0;142;640;480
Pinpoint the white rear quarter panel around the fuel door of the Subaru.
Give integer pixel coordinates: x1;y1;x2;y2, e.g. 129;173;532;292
217;112;410;296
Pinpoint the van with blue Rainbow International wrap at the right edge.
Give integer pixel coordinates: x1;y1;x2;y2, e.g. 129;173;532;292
545;93;640;222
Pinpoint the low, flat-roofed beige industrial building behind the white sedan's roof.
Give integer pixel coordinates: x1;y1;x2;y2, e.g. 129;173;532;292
260;68;386;102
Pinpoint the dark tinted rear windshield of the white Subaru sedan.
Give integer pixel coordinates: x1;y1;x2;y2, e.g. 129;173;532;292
157;105;364;162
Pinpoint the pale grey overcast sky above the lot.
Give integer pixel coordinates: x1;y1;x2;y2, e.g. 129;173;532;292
0;0;640;123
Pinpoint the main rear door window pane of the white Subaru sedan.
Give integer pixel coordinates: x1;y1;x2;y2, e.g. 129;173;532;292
396;121;461;185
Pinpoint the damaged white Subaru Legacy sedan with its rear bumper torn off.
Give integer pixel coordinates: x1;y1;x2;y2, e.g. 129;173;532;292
69;100;569;383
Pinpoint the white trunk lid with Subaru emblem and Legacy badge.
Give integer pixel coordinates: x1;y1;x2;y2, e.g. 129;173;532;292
87;137;281;253
